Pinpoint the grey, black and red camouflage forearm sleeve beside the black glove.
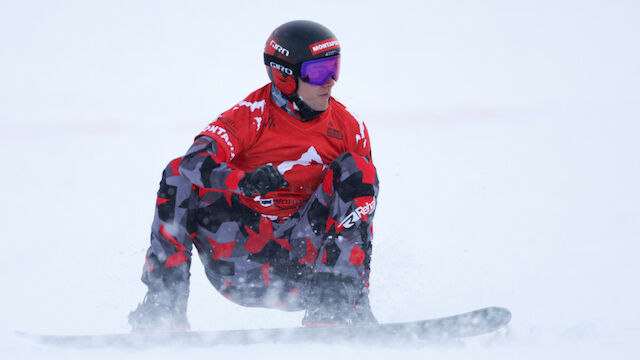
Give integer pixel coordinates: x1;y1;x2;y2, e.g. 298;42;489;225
177;136;244;191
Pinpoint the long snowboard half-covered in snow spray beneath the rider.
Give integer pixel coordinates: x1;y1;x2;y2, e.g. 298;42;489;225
18;307;511;348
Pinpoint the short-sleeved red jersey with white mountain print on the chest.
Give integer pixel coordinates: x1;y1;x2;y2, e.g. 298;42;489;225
191;84;371;217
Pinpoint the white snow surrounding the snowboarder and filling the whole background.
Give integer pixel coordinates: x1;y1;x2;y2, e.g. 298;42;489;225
0;0;640;359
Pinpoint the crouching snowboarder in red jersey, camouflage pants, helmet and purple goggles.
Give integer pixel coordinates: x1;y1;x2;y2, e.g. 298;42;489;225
129;21;378;331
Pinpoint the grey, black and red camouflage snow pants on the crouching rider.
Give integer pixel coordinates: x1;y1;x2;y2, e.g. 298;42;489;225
142;153;378;311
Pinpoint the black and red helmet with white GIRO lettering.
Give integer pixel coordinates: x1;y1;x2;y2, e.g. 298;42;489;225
264;20;340;95
